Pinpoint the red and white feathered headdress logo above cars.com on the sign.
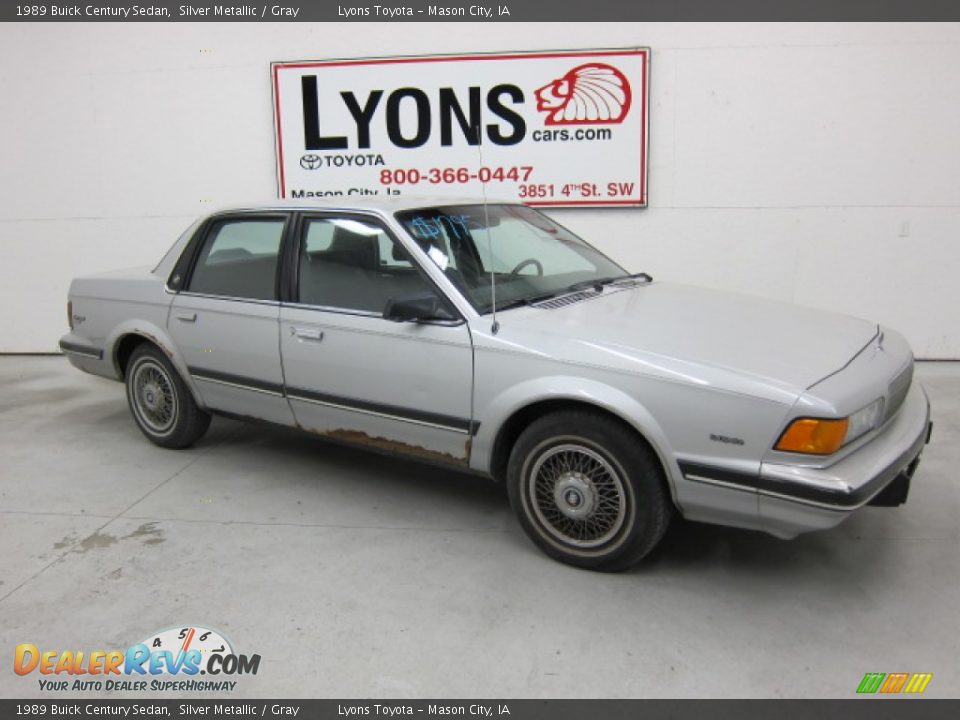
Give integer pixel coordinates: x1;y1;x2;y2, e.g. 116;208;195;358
536;63;630;125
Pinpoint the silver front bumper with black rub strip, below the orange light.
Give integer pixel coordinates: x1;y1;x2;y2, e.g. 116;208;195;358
757;383;931;537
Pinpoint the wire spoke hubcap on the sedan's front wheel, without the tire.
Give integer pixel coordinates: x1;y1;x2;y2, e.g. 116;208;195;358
528;444;626;548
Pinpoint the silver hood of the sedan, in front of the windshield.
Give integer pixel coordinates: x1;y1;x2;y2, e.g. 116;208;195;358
501;283;879;393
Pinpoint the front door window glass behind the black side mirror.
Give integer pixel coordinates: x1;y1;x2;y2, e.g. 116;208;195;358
298;218;431;315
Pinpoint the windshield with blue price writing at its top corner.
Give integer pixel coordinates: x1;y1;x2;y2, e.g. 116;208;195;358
397;205;626;313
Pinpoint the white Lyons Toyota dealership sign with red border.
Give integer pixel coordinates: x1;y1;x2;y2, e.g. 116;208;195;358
271;48;650;206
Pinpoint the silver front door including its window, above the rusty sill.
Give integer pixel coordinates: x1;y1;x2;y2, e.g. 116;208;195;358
280;214;473;464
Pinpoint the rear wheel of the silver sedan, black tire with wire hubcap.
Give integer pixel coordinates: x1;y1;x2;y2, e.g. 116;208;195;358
125;343;210;449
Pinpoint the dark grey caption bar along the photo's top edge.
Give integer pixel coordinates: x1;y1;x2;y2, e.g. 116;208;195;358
0;0;960;22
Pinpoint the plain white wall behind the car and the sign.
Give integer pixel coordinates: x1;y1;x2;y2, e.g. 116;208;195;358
0;23;960;358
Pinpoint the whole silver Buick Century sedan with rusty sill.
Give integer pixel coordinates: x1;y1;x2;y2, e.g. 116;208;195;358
60;198;931;570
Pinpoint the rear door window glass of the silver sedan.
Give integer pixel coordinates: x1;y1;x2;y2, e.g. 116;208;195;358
188;218;284;300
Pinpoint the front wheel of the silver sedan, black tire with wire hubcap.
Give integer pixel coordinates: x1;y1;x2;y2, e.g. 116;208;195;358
507;410;673;572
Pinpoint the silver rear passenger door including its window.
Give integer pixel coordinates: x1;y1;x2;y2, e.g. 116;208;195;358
167;213;293;425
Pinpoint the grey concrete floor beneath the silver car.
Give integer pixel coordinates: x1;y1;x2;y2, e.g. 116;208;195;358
0;357;960;698
